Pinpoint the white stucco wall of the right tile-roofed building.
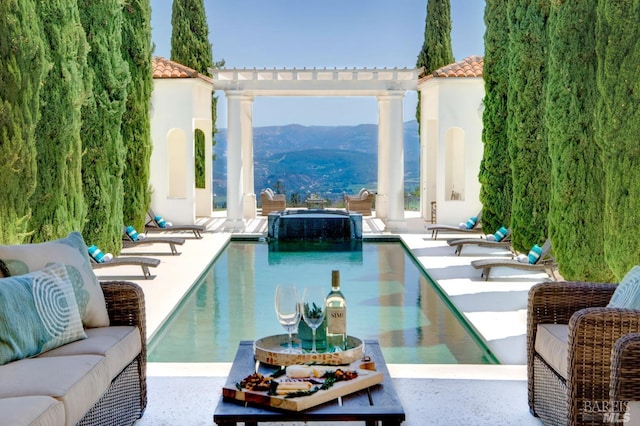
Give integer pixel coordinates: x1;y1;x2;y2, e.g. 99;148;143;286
418;77;484;225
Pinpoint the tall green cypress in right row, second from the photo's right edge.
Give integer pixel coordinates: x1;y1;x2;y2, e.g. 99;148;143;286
546;0;613;282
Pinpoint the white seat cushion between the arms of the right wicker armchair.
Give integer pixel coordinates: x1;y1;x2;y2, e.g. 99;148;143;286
535;324;569;379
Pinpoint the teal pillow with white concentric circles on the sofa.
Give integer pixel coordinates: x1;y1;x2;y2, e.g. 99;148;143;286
0;263;87;365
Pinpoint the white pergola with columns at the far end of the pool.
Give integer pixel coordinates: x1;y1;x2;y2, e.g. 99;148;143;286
210;68;423;230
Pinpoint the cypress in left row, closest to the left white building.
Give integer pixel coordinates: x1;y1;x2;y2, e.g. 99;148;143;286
122;0;153;229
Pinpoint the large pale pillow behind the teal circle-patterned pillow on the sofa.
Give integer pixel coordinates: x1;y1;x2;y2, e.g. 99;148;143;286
0;232;109;327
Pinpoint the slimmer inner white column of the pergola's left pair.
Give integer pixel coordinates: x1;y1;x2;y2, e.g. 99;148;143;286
240;95;256;219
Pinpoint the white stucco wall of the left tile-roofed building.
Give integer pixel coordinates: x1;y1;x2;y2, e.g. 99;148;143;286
149;78;213;224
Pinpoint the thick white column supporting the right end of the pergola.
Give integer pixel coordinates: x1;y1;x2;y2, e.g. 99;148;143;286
376;90;407;230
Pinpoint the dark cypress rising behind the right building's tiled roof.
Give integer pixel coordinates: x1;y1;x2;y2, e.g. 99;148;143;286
416;0;454;126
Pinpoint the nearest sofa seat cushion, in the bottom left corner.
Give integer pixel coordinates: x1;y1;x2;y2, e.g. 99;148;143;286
0;395;64;426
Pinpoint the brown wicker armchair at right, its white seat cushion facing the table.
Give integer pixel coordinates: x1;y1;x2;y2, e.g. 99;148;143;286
527;282;640;425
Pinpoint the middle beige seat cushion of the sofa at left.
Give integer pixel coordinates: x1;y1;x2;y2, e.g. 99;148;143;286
0;355;111;426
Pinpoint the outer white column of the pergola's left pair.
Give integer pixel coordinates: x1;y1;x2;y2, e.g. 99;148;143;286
225;90;244;231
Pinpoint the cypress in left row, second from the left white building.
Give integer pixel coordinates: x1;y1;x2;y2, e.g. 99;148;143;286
78;0;129;253
